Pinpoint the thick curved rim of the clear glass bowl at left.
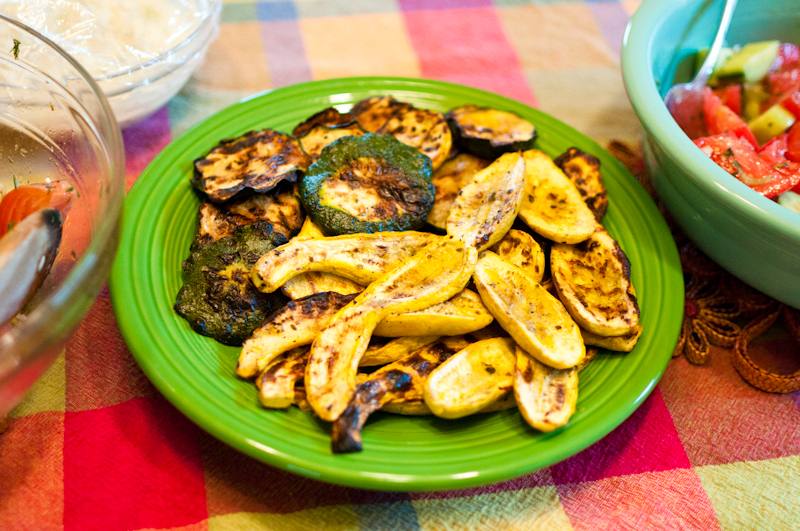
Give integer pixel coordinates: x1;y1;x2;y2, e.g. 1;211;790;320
0;14;126;378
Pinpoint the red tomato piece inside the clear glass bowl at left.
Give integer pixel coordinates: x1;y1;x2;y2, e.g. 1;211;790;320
0;181;77;237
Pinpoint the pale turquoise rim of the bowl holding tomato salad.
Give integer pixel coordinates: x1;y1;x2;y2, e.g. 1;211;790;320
621;0;800;238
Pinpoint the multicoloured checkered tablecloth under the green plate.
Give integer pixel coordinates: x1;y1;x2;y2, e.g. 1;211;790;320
0;0;800;531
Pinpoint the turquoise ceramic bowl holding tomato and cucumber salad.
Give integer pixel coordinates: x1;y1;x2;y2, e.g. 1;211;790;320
622;0;800;308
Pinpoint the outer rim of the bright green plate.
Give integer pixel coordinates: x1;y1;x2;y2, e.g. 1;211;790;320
109;77;683;491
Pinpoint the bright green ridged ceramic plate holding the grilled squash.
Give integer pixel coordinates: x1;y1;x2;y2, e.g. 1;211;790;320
111;78;683;491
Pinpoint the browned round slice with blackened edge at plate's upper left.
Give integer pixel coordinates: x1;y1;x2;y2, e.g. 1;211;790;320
192;129;311;203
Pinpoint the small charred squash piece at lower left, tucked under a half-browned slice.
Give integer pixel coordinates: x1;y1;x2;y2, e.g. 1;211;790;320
256;347;309;409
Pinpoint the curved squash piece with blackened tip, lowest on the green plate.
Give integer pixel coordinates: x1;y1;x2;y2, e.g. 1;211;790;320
331;337;469;454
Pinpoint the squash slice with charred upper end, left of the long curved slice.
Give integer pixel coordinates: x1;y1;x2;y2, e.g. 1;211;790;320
236;291;355;378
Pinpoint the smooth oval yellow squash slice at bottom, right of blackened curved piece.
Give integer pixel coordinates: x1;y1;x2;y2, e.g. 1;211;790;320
425;337;516;419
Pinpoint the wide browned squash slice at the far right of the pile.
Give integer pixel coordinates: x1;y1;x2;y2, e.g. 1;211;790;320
550;227;639;336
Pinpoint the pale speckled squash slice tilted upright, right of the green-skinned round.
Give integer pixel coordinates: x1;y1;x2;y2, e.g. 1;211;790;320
447;153;525;251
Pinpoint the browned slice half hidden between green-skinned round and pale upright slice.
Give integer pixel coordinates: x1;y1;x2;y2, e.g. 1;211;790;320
427;153;490;231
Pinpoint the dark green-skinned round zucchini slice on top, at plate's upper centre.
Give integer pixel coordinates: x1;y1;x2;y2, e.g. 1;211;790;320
300;133;435;236
